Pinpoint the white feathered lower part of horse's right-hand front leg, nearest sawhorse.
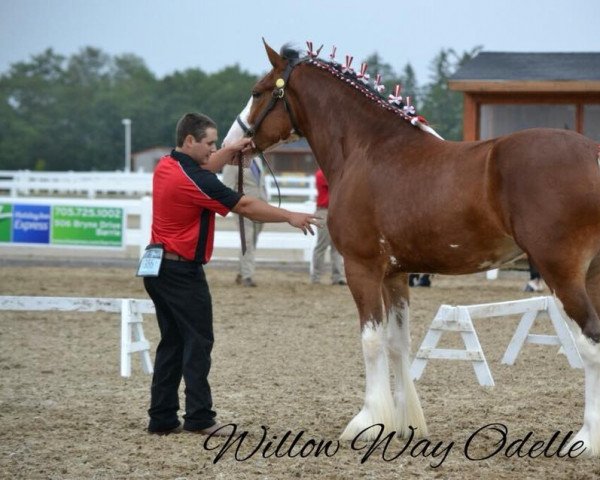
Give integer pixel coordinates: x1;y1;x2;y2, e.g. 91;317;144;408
387;306;427;437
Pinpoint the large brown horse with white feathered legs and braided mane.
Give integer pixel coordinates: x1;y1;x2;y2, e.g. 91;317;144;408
227;40;600;456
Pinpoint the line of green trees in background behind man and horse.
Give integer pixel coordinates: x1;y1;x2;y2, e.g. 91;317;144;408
0;43;479;170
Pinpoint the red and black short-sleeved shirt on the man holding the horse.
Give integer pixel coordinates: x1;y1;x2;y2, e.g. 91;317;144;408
151;150;242;263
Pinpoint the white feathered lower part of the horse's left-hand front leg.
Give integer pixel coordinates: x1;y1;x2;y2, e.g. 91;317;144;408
340;322;397;440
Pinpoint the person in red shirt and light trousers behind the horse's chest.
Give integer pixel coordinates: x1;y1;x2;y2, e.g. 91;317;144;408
310;169;346;285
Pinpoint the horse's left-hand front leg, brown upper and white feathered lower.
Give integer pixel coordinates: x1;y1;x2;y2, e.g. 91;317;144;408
340;258;398;440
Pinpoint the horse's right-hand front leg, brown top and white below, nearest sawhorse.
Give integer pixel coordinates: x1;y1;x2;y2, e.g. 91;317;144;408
383;274;427;437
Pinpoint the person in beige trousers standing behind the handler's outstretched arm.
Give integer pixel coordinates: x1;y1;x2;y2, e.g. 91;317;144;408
223;157;268;287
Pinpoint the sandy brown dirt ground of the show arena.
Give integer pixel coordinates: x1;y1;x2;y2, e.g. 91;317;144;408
0;265;600;479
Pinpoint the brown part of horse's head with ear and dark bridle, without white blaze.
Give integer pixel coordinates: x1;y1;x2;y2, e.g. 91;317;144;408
248;39;301;151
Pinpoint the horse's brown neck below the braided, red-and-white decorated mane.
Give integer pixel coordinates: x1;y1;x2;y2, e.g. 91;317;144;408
295;66;416;182
